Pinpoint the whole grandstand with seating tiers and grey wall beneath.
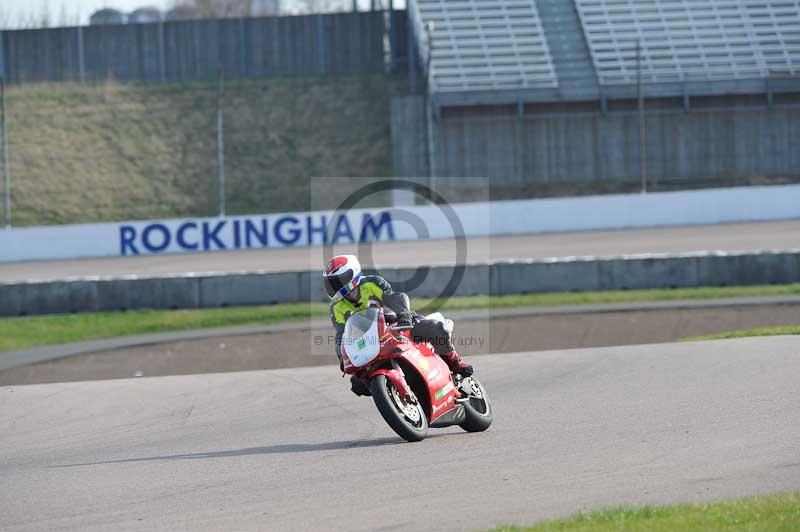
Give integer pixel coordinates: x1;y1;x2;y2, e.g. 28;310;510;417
395;0;800;190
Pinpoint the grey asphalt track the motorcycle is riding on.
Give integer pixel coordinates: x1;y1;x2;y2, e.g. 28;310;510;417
0;337;800;530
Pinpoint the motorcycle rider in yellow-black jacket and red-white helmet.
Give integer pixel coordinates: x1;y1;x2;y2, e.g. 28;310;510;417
322;255;472;395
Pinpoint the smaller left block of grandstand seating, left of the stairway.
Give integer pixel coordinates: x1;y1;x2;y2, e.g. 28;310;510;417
408;0;558;92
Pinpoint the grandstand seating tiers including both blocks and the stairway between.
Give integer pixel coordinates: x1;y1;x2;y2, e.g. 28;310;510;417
408;0;800;103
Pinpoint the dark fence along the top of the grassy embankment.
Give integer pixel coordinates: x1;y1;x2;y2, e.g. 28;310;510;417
0;10;407;84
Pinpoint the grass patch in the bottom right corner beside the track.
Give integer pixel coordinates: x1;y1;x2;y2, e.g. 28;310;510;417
495;492;800;532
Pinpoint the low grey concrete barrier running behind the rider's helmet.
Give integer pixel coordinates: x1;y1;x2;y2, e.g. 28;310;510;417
0;250;800;316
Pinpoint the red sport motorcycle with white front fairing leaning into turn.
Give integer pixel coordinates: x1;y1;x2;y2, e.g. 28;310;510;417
342;307;492;441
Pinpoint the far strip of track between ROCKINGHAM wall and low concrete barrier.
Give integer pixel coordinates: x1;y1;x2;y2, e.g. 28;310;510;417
0;220;800;282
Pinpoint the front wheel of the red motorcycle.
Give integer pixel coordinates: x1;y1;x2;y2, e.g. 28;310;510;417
369;375;428;442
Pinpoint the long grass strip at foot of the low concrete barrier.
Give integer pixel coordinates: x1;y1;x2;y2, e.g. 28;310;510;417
0;284;800;351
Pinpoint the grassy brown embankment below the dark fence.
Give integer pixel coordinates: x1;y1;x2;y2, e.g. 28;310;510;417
6;76;396;226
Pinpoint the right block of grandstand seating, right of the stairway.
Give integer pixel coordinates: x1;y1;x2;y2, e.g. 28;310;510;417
575;0;800;85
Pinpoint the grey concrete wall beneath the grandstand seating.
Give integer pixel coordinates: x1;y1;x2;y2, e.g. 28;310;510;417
434;94;800;188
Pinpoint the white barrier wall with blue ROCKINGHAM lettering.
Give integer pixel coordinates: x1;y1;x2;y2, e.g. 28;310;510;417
0;185;800;262
